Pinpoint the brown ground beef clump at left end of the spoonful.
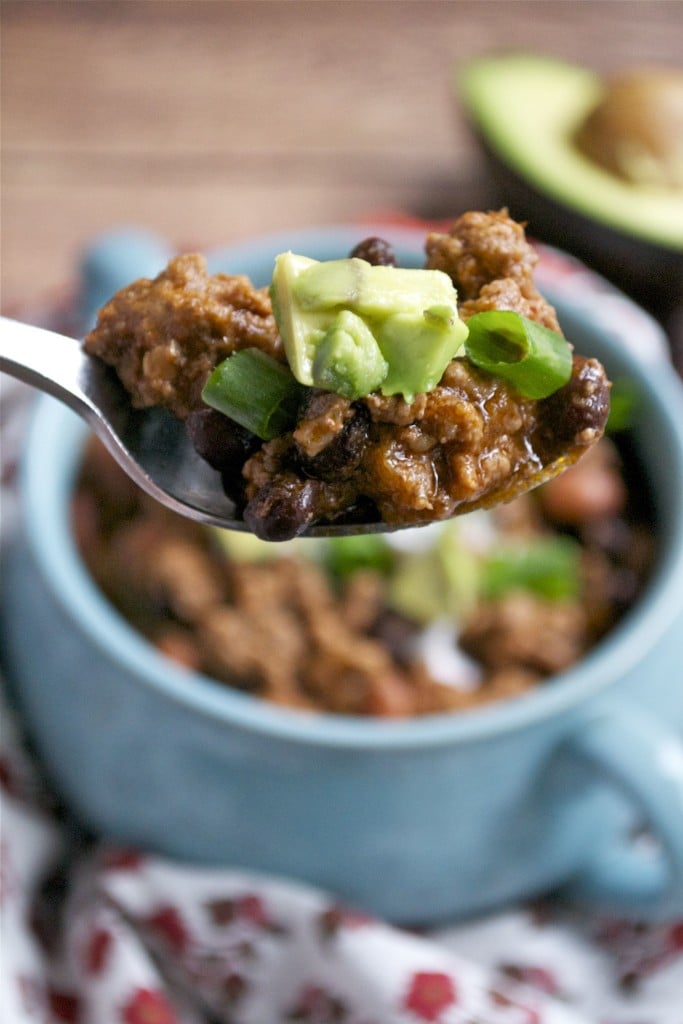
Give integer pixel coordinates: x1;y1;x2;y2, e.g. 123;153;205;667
85;254;283;420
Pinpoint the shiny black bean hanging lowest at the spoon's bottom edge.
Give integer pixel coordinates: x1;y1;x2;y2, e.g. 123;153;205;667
243;473;319;541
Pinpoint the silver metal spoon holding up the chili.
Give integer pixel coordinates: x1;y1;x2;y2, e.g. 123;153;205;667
0;316;593;537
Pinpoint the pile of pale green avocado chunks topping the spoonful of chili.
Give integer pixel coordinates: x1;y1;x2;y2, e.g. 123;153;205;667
270;253;467;401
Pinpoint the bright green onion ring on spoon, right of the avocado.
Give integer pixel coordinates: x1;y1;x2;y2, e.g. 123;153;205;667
465;309;571;398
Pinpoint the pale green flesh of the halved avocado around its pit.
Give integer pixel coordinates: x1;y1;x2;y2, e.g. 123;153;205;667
456;54;683;252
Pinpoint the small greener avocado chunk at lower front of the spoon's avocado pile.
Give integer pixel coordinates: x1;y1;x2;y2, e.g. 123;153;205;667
313;309;389;399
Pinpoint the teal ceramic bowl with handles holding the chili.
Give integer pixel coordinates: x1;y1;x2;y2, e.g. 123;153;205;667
3;227;683;923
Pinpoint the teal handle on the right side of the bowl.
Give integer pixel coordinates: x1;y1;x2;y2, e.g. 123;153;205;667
566;700;683;919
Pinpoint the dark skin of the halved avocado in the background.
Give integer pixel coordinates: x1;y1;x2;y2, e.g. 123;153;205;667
471;132;683;324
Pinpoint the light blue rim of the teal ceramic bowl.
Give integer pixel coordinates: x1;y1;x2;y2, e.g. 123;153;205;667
20;224;683;751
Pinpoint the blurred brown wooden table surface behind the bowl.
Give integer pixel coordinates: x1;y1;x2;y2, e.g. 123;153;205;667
1;0;683;311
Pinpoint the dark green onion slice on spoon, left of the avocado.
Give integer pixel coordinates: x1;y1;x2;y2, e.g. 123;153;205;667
202;348;304;440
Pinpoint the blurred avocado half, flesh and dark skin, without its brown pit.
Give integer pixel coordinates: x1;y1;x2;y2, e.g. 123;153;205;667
456;53;683;319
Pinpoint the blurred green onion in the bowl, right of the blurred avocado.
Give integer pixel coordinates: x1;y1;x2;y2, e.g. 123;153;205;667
480;537;581;601
